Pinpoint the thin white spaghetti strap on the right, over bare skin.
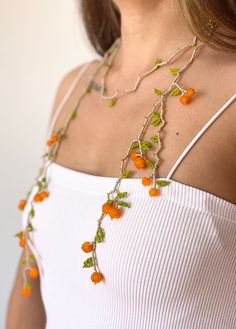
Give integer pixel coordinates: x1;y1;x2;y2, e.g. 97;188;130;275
166;94;236;179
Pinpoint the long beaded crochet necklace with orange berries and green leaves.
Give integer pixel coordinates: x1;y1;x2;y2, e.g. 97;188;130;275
15;37;203;297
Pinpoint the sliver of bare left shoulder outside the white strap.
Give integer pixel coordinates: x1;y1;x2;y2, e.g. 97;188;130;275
49;59;98;121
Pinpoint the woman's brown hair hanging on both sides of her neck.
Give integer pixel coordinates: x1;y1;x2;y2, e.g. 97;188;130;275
80;0;236;56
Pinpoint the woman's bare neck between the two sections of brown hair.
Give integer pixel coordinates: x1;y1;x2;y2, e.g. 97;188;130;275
111;0;194;74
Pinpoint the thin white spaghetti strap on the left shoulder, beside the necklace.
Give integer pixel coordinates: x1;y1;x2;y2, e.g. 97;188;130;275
47;61;92;140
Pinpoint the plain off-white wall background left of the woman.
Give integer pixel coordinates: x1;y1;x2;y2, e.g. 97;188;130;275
0;0;99;322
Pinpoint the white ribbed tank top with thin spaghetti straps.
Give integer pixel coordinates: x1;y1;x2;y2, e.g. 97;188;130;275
22;62;236;329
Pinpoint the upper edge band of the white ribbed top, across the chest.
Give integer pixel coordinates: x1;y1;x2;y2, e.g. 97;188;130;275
47;162;236;224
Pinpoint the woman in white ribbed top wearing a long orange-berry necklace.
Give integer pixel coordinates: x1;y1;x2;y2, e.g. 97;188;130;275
7;0;236;329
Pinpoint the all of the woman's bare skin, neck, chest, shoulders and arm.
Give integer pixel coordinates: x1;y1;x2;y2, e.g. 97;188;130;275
6;0;236;329
